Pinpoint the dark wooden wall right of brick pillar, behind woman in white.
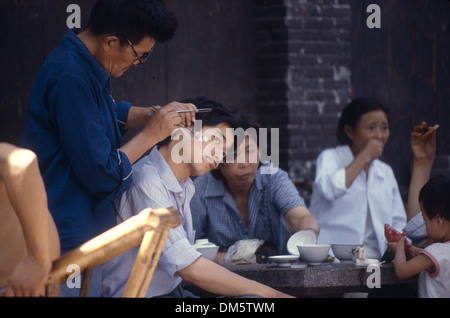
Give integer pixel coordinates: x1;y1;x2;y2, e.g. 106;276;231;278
351;0;450;185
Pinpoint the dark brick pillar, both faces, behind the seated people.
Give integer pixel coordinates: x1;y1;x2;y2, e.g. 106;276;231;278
256;0;351;198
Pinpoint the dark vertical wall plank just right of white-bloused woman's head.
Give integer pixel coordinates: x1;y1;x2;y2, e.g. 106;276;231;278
383;0;416;186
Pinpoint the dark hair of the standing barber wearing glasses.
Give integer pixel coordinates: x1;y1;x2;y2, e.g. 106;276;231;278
87;0;178;44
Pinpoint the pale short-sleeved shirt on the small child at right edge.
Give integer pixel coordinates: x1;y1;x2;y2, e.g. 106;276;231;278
419;241;450;298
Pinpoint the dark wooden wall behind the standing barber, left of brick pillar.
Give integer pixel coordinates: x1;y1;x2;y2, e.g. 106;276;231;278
0;0;255;144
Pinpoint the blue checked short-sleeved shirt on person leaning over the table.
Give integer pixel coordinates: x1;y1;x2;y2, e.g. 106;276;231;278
191;164;305;254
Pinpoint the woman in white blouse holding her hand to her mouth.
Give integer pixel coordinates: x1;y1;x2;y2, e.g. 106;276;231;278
310;98;406;259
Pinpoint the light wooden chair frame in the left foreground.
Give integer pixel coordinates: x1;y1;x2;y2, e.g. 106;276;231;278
46;208;181;297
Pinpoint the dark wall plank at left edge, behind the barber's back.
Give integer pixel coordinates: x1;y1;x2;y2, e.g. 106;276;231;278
0;0;44;145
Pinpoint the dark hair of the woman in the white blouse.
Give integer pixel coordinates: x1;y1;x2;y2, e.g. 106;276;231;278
337;97;389;145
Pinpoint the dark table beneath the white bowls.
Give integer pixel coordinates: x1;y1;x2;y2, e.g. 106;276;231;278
222;263;418;297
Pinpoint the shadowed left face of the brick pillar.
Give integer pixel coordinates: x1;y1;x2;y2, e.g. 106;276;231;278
255;0;290;169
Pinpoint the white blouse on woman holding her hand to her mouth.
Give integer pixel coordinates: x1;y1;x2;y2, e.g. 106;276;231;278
310;146;406;258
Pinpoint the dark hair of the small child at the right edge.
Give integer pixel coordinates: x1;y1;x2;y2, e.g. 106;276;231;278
419;175;450;221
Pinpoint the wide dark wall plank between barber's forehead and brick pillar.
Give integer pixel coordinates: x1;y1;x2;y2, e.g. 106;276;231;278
167;0;255;110
